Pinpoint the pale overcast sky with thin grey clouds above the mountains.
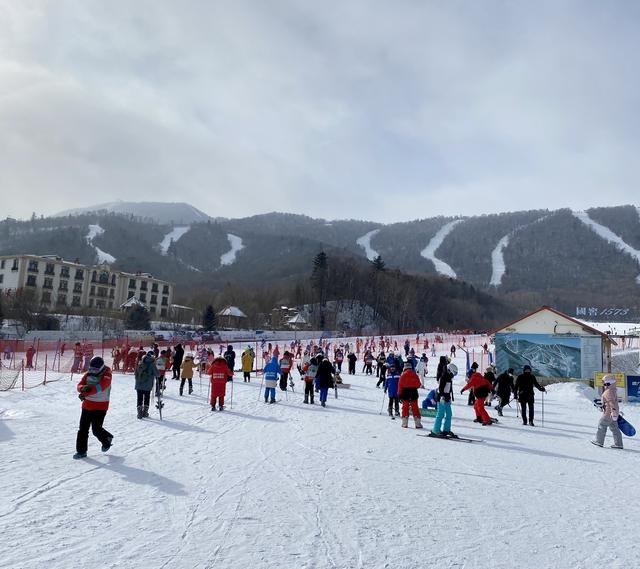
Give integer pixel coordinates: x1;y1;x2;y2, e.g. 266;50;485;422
0;0;640;222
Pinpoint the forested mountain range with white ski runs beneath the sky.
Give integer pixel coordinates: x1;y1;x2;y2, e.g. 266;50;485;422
0;202;640;318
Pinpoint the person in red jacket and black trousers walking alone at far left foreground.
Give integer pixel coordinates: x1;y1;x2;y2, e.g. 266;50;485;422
73;356;113;459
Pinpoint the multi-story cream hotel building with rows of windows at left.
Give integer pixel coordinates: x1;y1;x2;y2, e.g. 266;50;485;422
0;255;174;318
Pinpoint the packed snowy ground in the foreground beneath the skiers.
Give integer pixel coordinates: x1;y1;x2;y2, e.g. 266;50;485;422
0;352;640;569
